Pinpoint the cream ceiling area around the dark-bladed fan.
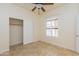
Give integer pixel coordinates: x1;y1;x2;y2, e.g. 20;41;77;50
15;3;63;13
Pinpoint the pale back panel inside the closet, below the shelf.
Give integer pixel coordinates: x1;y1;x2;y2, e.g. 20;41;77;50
10;25;23;46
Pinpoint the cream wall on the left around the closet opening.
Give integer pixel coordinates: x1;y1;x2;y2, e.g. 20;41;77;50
0;4;37;53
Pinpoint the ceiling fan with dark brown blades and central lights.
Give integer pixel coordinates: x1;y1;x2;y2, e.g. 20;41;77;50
32;3;54;12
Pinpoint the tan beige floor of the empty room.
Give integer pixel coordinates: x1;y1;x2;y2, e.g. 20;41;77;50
1;41;79;56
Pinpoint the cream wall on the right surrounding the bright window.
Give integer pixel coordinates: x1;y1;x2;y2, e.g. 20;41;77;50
40;4;78;50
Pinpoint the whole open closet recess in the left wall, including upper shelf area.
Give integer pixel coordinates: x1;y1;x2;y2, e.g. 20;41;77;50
9;18;23;47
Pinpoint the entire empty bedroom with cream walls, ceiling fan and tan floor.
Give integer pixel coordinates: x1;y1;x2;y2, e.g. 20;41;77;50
0;3;79;56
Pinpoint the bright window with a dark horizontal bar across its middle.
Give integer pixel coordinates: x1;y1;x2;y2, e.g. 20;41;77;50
46;19;58;37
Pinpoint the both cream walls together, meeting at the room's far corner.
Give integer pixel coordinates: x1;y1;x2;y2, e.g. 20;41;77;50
0;4;78;53
